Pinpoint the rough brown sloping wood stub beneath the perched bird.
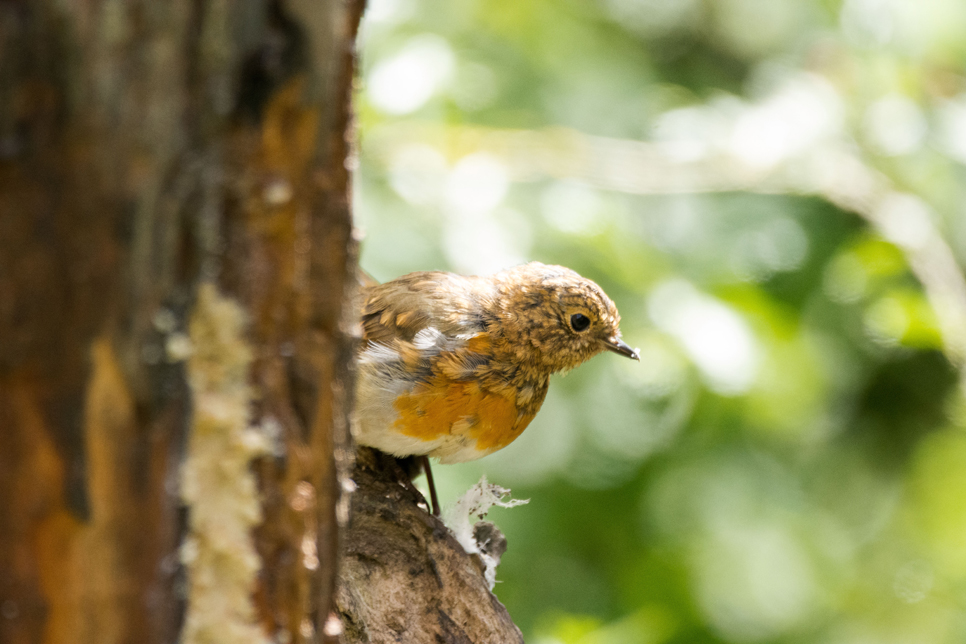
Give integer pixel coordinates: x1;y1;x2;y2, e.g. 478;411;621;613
336;448;523;644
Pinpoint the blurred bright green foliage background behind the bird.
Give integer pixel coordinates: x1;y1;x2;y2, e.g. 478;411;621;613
355;0;966;644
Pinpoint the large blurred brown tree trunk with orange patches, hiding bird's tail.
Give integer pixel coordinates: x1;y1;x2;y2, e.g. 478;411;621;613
0;0;362;644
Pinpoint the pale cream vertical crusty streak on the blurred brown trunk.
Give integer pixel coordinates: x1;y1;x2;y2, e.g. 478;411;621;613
181;283;269;644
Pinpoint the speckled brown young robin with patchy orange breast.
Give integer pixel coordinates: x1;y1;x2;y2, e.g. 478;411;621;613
354;262;639;512
